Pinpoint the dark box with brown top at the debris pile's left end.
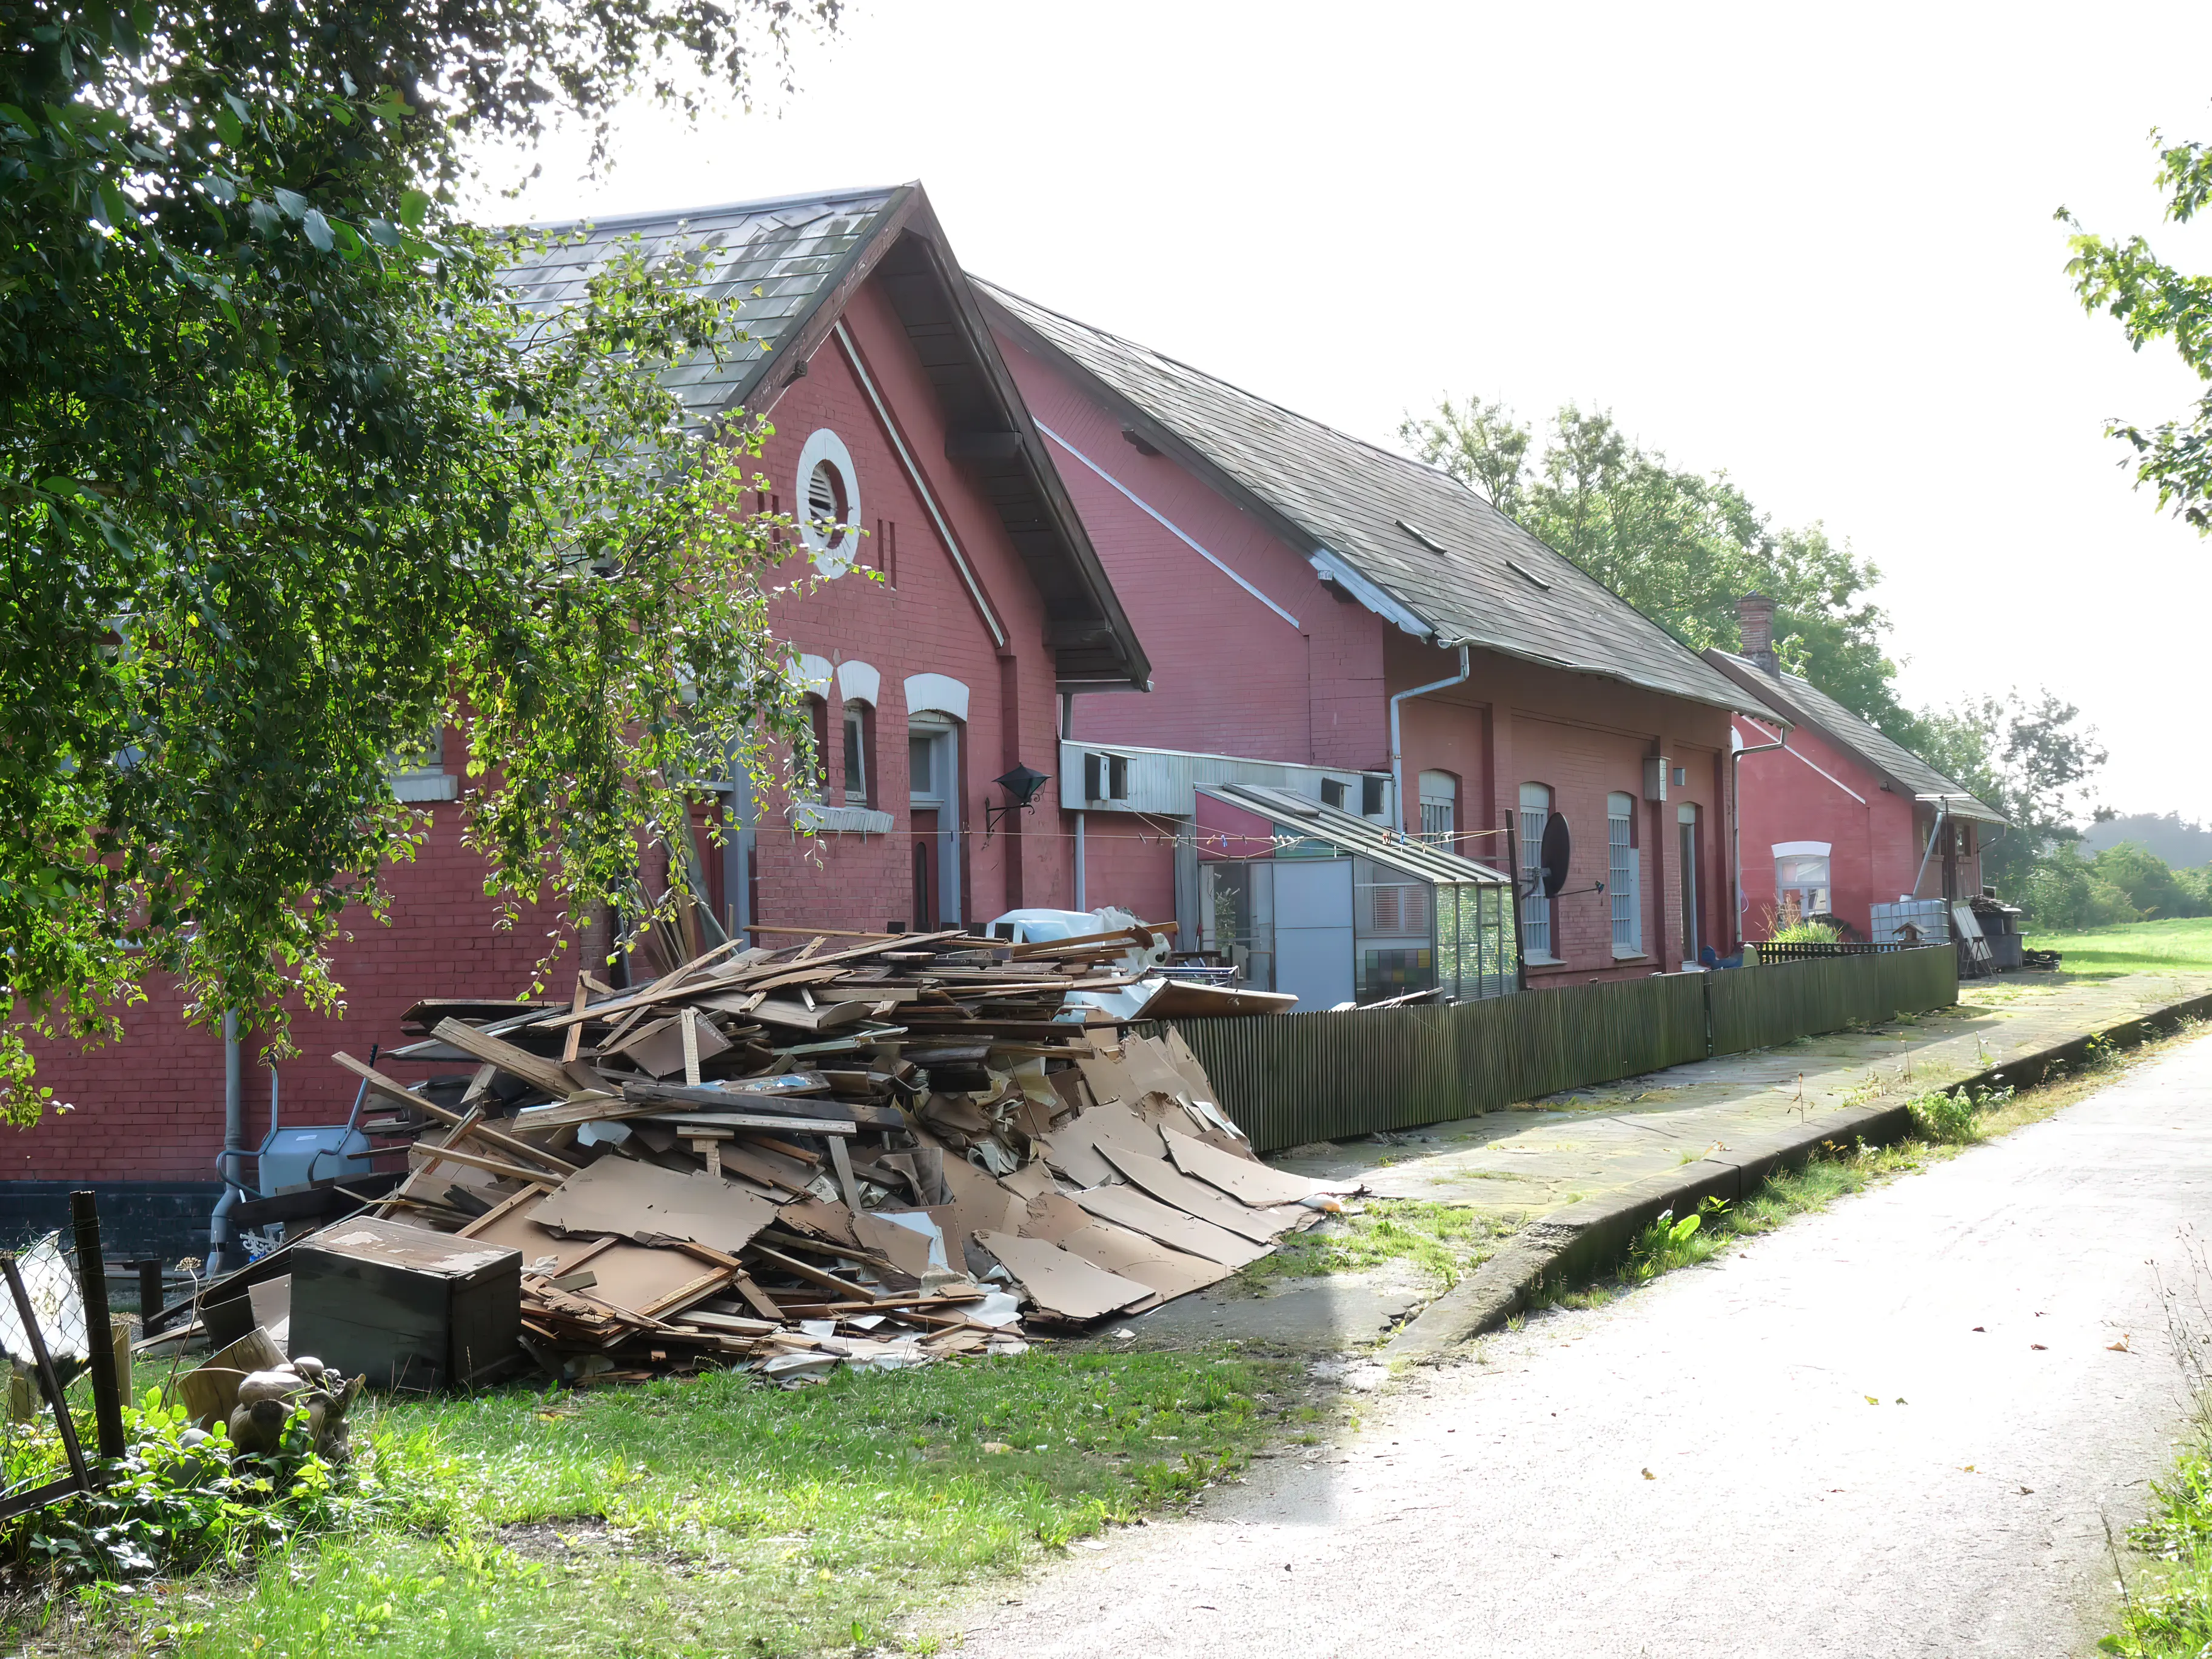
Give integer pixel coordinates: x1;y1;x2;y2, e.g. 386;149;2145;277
290;1219;522;1392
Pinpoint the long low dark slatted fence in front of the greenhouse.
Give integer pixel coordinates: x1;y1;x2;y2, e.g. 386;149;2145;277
1172;945;1957;1153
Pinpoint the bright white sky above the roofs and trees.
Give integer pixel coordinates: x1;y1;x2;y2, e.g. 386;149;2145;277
497;0;2212;819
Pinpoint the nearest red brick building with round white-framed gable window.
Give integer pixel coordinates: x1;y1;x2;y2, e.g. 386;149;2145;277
17;184;1150;1247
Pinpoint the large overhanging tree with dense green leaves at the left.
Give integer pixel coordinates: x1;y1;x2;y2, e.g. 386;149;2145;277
0;0;839;1122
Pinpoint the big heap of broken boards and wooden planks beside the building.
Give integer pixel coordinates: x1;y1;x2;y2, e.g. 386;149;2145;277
246;927;1341;1385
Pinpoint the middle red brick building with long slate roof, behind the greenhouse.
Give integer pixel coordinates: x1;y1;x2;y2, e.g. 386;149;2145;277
980;283;1761;1002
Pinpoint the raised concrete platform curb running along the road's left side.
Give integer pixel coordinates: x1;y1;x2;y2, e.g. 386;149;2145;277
1382;996;2212;1361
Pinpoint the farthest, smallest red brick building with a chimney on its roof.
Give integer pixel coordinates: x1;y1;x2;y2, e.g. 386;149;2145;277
1706;593;2006;940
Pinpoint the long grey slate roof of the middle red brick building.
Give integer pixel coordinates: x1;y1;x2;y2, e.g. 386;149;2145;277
976;279;1757;710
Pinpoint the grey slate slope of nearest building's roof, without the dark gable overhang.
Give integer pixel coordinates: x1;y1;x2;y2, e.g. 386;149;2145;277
506;186;911;418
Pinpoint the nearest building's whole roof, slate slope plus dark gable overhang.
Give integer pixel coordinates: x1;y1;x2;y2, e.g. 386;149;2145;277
504;184;1153;690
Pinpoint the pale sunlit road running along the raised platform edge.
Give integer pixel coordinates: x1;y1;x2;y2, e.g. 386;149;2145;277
960;1040;2212;1659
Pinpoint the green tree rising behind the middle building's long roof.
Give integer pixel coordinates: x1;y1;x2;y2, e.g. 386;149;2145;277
1398;398;1915;741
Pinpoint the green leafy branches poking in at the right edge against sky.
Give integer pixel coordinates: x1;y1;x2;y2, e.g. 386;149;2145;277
2057;130;2212;535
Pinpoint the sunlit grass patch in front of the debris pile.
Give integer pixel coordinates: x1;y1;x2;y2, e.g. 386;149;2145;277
25;1349;1321;1659
